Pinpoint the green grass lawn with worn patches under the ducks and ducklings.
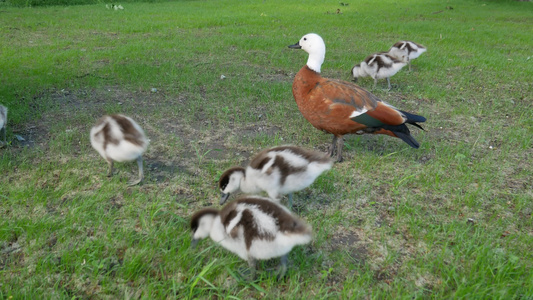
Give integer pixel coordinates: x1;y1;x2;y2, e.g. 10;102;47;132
0;0;533;299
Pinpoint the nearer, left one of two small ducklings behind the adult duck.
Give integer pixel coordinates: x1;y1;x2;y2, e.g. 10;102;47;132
352;52;407;90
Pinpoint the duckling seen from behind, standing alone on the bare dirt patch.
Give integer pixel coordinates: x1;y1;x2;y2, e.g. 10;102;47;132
91;115;149;186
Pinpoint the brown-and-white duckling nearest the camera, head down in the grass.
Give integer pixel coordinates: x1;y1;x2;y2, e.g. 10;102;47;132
191;196;312;278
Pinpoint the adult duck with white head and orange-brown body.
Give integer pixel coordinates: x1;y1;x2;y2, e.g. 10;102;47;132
289;34;426;161
